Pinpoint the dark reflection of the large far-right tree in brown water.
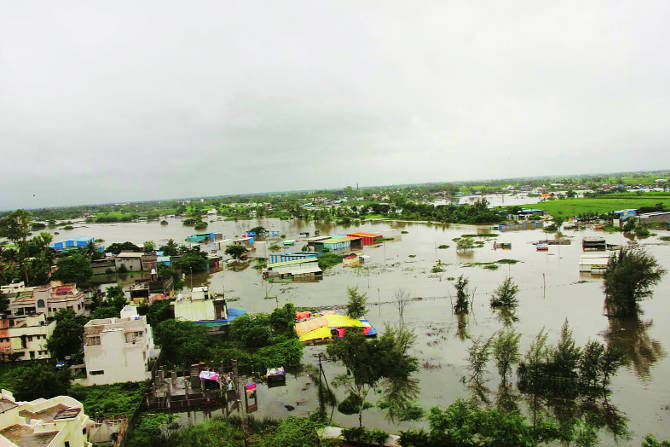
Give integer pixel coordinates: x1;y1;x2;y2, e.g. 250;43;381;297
603;318;665;378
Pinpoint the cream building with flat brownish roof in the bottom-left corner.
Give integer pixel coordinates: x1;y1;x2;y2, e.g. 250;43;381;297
0;390;92;447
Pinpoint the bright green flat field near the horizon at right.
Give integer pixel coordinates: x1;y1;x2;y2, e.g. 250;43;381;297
526;193;670;217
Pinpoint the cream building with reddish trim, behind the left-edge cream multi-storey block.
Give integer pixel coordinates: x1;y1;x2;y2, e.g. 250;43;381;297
9;281;84;318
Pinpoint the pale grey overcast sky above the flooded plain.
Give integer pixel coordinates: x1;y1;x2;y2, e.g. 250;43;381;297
0;0;670;209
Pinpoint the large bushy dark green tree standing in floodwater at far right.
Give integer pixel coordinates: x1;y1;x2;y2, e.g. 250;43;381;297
604;247;665;317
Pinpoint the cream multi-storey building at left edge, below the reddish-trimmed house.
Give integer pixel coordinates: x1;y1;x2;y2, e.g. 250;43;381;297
0;313;56;361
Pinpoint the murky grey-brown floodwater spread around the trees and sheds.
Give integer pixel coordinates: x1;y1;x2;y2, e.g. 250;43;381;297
48;219;670;446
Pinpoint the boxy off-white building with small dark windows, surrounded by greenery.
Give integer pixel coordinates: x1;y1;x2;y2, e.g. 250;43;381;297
84;306;158;385
